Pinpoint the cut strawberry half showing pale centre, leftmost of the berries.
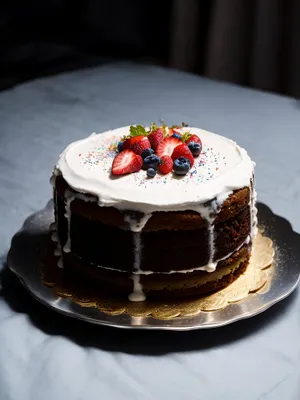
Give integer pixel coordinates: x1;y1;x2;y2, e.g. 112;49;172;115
111;149;143;175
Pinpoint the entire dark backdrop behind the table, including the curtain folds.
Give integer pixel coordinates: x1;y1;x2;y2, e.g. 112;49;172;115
0;0;300;98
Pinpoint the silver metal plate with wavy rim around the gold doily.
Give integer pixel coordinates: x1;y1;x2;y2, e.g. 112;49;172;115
8;201;300;331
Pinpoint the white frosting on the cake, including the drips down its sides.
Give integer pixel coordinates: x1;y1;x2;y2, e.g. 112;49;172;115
51;127;257;301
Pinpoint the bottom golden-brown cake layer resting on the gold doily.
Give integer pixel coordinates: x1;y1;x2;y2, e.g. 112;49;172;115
63;245;250;299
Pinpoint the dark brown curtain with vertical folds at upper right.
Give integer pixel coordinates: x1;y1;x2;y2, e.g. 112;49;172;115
169;0;300;98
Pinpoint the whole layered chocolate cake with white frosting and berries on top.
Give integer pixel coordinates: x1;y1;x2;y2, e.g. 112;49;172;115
51;124;257;301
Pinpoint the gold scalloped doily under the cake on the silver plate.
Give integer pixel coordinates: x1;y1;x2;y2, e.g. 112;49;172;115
42;232;275;320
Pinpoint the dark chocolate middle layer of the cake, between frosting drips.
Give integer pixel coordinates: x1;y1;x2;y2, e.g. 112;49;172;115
57;193;251;272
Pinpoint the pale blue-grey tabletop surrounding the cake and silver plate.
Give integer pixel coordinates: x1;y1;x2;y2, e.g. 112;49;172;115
0;62;300;400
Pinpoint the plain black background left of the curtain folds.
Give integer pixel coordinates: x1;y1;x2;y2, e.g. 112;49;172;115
0;0;172;89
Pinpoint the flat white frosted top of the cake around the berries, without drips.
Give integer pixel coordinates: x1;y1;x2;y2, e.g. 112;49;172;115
54;126;254;212
